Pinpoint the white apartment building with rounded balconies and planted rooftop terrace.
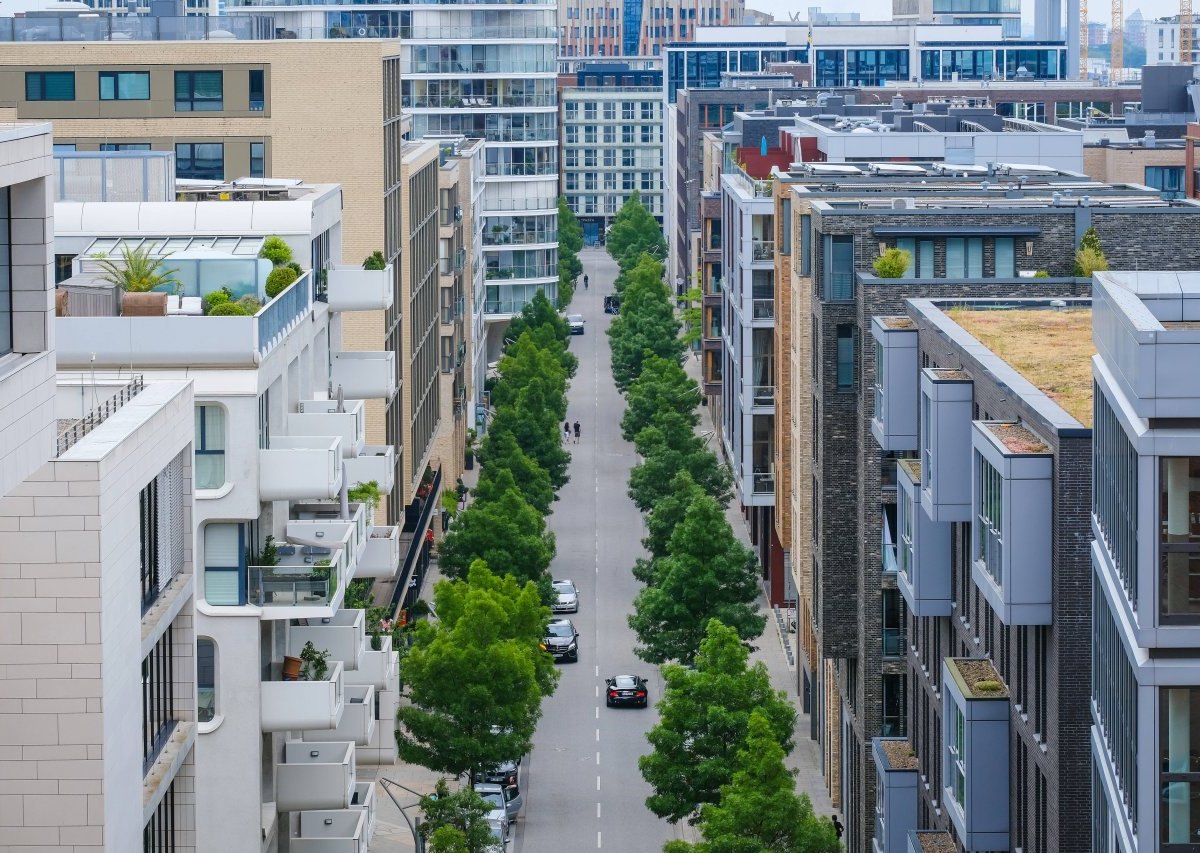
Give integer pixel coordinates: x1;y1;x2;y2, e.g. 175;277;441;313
56;173;407;853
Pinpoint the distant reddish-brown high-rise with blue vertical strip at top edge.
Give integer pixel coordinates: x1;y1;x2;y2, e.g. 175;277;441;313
558;0;745;56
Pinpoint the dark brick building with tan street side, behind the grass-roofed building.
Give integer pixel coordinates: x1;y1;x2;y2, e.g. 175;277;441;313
775;170;1200;849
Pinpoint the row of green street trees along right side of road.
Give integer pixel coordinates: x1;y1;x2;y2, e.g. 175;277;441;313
607;197;841;853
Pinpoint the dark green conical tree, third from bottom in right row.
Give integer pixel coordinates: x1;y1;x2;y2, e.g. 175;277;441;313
629;494;766;663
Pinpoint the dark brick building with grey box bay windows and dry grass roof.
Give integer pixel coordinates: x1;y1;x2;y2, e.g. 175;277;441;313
871;295;1093;852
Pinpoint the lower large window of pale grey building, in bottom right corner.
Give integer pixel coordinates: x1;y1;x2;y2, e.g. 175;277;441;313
1158;687;1200;853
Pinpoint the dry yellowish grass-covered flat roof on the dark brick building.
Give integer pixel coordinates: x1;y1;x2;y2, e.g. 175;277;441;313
946;306;1096;427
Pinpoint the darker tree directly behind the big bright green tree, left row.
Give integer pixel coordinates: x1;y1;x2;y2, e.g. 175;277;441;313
438;484;554;582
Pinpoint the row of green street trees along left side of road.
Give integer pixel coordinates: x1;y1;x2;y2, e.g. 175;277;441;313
396;293;577;853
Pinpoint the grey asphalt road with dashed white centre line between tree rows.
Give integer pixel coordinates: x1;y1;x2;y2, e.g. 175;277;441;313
514;250;677;853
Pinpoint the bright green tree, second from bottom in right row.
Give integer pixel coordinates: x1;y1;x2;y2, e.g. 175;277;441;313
637;619;796;823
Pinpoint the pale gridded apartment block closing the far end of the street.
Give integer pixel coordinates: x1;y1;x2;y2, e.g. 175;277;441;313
560;64;664;245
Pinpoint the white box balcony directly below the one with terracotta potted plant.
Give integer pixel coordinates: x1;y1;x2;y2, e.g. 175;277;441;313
275;732;355;811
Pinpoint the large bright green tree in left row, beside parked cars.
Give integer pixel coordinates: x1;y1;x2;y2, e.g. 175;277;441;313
396;561;558;779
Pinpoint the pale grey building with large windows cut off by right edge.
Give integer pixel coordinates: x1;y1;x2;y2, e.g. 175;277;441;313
1091;272;1200;853
